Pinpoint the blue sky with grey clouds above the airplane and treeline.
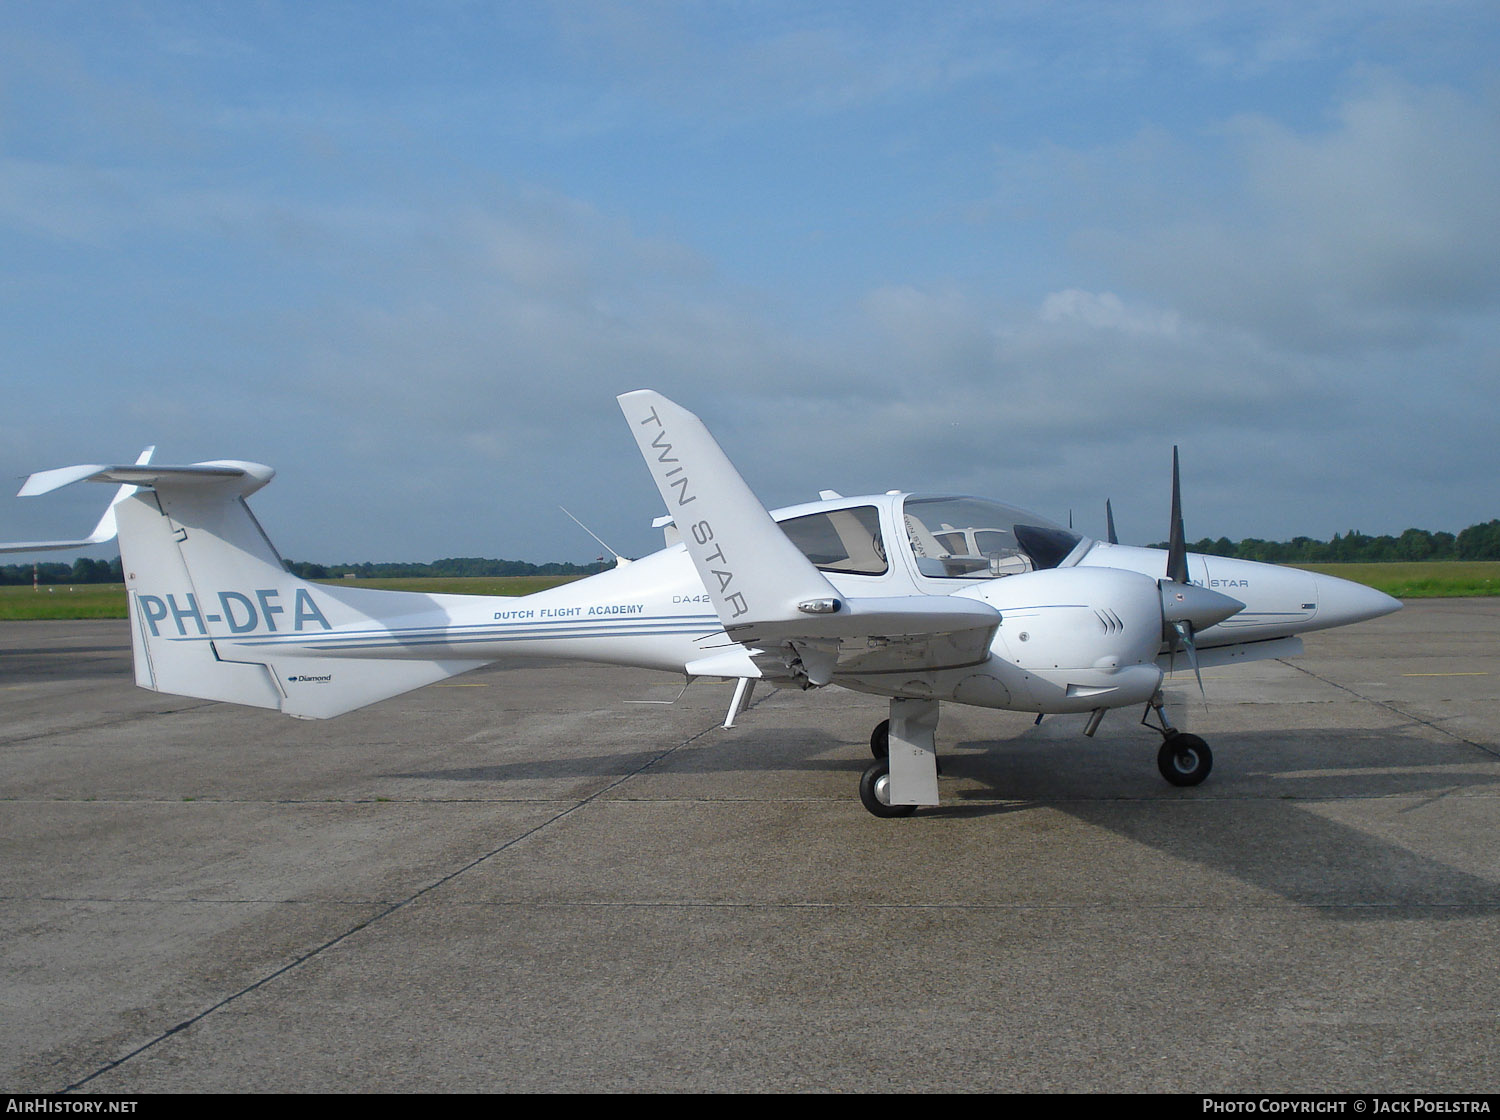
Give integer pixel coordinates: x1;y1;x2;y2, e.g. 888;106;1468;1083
0;0;1500;562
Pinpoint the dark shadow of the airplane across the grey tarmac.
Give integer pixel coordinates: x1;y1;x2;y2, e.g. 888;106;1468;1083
384;723;1500;921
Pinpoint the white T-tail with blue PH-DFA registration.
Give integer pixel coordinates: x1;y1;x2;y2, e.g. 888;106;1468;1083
21;460;486;718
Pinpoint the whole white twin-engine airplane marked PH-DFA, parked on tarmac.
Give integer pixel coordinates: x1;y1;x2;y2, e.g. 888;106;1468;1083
21;390;1401;817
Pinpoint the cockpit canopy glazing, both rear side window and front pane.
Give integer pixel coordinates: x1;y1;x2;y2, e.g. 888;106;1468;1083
780;496;1083;579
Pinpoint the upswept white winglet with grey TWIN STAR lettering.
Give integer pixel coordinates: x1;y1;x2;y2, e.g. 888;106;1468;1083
617;388;842;640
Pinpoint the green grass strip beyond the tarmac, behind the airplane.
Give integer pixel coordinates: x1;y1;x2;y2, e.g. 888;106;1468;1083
0;561;1500;622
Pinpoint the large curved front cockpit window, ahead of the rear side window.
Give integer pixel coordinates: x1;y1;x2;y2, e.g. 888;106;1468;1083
903;498;1083;579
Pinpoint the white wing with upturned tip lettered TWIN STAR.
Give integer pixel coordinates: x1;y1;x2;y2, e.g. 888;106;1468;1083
618;390;999;685
